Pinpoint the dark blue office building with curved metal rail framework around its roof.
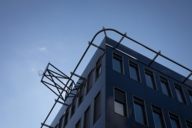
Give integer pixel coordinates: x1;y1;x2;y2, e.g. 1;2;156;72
41;29;192;128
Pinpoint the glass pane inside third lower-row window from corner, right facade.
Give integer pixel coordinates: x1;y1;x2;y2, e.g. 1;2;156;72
153;112;163;128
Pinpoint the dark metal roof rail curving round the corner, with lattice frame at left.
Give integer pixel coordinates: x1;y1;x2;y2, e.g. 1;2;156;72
41;28;192;128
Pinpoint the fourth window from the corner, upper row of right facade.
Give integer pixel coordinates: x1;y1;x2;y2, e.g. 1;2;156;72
160;77;171;96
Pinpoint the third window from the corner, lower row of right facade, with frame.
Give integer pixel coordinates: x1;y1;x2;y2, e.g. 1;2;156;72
152;106;165;128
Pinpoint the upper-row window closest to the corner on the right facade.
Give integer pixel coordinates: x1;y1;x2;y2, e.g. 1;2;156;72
113;53;123;74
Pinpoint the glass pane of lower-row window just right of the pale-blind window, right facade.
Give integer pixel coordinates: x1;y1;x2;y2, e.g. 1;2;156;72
134;104;145;124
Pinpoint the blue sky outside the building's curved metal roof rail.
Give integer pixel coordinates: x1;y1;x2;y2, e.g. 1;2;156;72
0;0;192;128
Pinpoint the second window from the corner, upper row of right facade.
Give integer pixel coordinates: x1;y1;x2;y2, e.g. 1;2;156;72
129;61;140;81
